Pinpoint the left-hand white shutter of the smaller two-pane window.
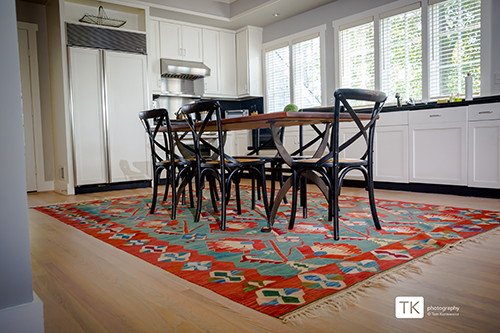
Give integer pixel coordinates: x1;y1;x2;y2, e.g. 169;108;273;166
265;44;290;112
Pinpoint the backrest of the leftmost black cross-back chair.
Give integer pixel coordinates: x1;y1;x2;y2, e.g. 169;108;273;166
139;109;183;165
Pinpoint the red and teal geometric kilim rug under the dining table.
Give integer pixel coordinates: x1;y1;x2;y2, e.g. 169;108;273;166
36;187;500;320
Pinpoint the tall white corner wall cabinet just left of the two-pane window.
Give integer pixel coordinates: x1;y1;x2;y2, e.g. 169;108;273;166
236;26;262;97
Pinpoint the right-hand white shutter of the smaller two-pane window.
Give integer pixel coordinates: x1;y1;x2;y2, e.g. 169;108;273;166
292;33;321;108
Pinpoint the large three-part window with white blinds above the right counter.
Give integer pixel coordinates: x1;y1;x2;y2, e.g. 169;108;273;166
333;0;484;104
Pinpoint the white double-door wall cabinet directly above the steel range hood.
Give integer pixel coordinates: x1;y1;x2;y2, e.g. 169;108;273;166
160;21;203;62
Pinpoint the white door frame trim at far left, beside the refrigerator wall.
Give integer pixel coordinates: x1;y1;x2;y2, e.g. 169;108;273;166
17;22;54;192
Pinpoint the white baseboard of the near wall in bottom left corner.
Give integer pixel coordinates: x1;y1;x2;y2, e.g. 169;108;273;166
0;292;44;333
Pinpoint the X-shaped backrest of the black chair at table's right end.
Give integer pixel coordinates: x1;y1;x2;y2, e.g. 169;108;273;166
334;89;387;159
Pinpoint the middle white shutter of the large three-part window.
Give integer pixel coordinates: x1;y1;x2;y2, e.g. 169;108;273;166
380;2;422;103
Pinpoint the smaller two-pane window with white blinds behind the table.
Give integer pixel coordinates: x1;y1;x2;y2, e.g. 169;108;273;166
264;28;323;112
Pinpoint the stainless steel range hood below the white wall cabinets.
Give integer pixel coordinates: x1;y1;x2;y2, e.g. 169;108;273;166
160;59;210;80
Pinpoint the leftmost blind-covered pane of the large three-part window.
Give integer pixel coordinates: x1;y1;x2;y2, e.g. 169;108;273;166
339;17;375;89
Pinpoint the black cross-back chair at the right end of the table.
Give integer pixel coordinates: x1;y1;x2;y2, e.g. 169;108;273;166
272;89;387;240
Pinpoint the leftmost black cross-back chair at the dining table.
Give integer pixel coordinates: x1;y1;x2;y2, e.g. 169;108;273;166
139;109;194;219
